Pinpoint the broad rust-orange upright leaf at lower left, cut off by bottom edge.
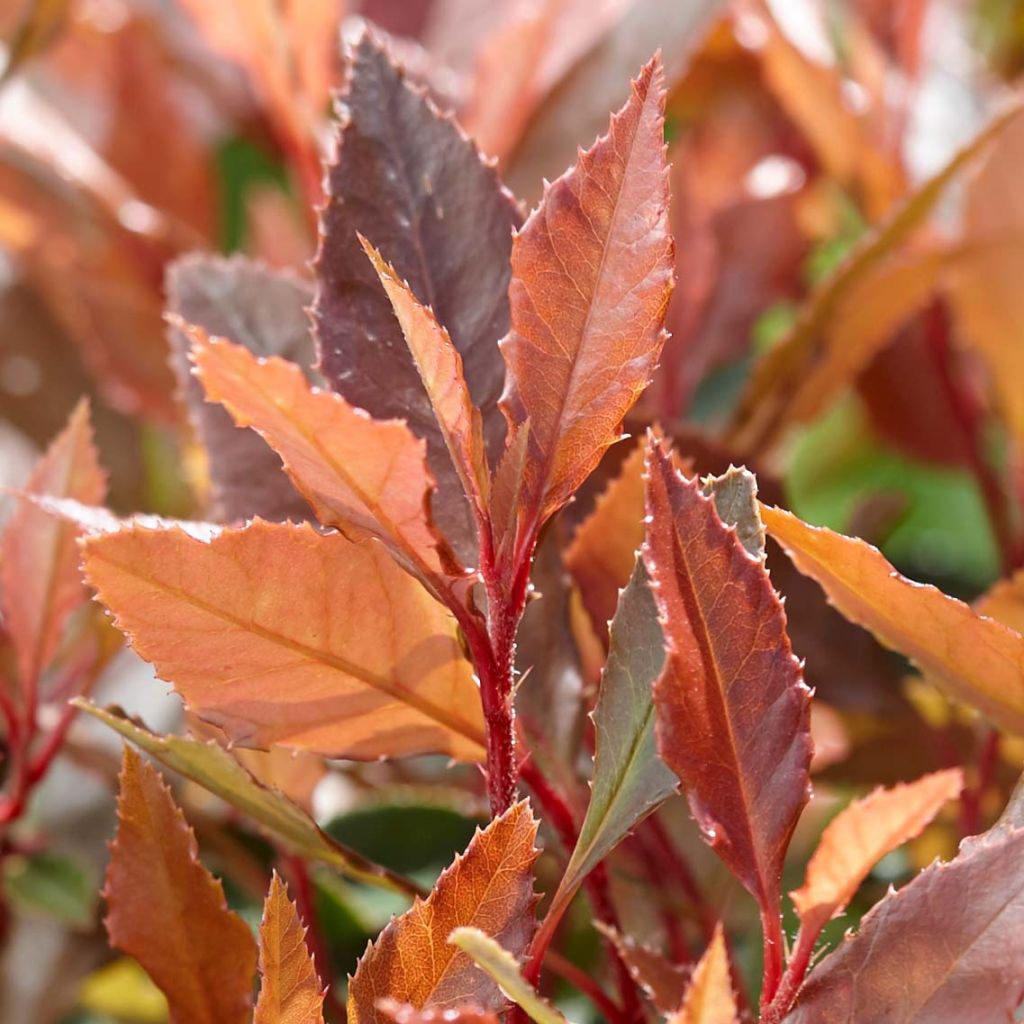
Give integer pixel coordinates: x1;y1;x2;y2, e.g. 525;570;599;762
103;746;256;1024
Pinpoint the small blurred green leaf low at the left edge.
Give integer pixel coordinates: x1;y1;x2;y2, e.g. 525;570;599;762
3;851;96;928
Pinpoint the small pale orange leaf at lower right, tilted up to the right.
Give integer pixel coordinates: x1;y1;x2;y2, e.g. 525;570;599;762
790;768;964;934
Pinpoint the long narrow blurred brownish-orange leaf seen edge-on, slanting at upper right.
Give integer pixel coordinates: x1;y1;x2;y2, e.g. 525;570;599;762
730;98;1021;452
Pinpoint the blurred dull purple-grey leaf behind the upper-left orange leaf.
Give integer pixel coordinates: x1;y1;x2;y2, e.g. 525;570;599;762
166;254;315;522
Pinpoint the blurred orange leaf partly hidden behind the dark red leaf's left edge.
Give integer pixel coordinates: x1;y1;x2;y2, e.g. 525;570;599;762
565;444;643;638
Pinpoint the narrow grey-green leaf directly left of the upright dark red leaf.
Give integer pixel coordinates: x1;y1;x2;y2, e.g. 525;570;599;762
552;560;679;906
